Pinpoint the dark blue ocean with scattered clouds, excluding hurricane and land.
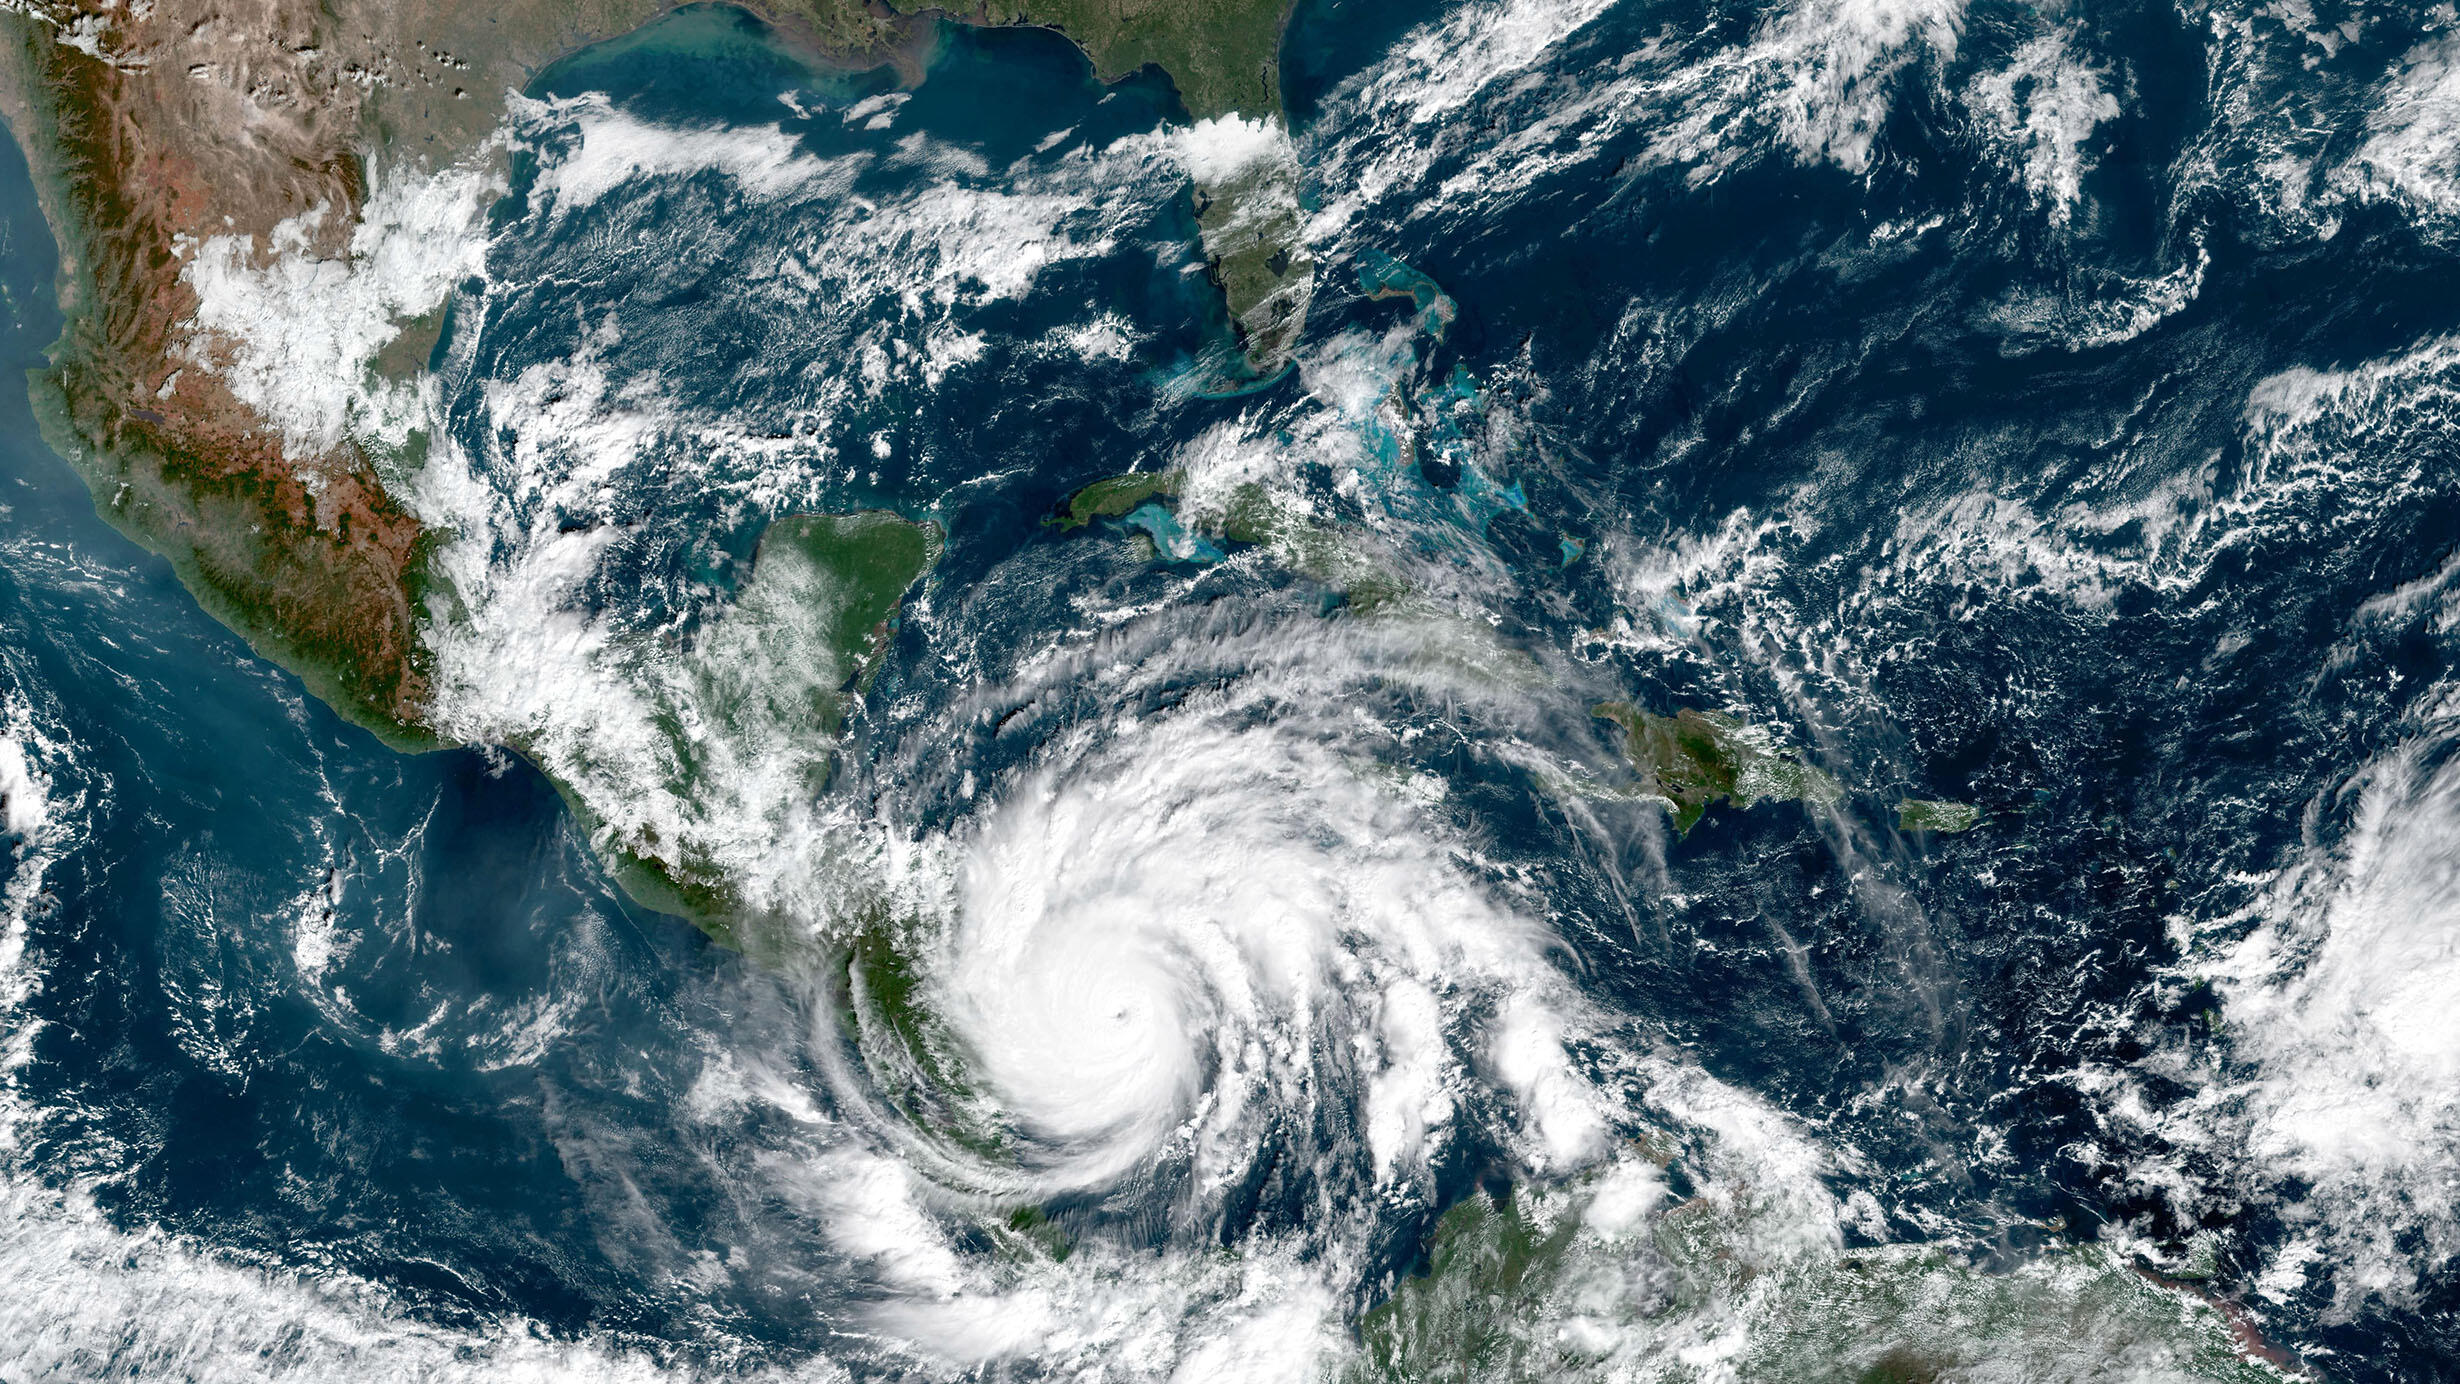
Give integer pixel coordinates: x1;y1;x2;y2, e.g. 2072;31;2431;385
14;2;2460;1379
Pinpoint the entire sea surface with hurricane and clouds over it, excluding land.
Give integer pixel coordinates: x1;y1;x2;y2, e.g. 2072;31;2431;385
0;5;2460;1379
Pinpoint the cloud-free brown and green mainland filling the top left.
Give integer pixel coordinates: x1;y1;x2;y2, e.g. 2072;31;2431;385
0;0;1289;766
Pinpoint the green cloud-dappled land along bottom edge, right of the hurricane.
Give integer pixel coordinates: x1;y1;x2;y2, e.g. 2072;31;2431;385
1348;1185;2288;1384
